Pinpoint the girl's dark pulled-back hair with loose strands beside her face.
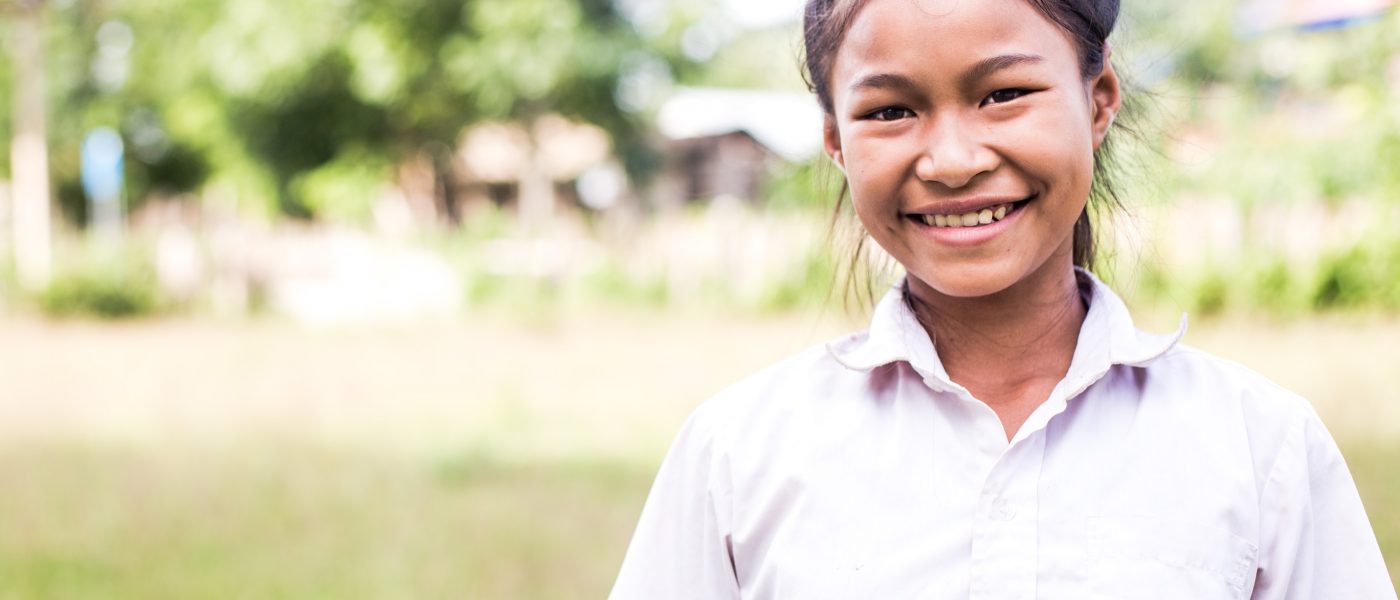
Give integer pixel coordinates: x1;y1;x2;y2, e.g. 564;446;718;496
802;0;1123;299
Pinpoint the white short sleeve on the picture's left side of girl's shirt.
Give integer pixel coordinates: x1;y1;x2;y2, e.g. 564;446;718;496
609;406;739;600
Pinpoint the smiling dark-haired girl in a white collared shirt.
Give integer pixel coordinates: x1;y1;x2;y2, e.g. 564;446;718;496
613;0;1396;600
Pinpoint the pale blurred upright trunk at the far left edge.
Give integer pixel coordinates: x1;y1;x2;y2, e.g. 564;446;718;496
10;3;52;290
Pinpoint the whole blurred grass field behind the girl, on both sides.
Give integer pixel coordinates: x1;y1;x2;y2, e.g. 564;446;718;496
0;309;1400;599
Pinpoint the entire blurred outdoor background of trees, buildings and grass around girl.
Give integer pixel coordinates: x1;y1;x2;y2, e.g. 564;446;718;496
0;0;1400;599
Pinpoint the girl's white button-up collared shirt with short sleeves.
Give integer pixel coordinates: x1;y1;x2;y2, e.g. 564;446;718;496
612;271;1396;600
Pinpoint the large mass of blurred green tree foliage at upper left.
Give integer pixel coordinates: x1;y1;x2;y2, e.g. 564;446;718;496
12;0;666;222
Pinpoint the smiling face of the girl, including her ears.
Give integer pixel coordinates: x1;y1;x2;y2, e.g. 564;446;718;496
825;0;1120;298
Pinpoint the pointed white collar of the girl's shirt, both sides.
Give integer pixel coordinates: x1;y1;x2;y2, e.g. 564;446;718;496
826;267;1186;386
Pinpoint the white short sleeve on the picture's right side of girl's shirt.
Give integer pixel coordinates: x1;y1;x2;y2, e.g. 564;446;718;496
1253;414;1396;600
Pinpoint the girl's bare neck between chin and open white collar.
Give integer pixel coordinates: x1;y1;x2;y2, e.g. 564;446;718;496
909;257;1086;416
